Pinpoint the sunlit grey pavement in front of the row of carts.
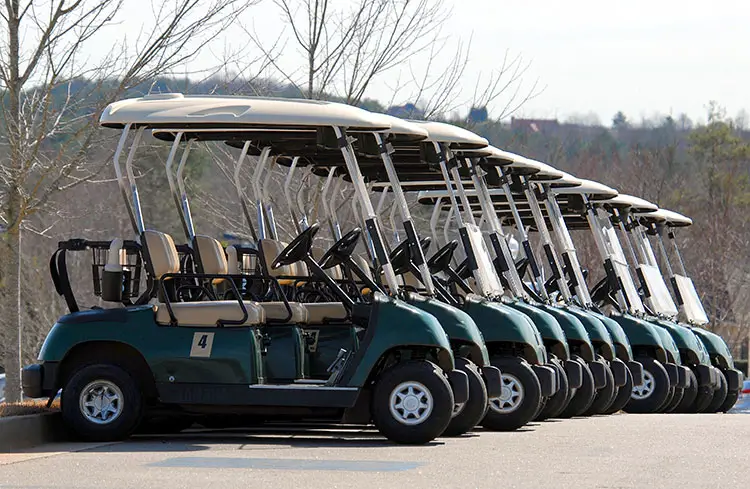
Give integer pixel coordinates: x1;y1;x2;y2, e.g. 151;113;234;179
0;414;750;489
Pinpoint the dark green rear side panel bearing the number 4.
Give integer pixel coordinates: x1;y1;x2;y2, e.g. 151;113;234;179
39;306;262;384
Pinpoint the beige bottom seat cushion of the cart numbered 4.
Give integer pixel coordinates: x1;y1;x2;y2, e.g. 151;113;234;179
155;301;265;328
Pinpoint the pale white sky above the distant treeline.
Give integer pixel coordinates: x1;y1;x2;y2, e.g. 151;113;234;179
91;0;750;124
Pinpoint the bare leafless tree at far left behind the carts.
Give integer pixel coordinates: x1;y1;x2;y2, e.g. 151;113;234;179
0;0;253;401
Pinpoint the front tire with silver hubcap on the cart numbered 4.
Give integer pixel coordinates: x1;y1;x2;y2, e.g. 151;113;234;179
371;360;454;445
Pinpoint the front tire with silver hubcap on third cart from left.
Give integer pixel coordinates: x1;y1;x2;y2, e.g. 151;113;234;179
482;357;542;431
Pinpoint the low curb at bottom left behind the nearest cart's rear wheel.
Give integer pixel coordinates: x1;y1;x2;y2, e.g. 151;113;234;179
0;413;66;453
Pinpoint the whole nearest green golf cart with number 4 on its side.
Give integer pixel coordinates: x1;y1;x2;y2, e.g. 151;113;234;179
23;94;468;443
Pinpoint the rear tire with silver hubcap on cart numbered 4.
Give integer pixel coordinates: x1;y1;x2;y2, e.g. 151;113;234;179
60;364;143;441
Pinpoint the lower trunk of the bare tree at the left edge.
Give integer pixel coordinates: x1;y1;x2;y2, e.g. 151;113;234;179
0;226;21;402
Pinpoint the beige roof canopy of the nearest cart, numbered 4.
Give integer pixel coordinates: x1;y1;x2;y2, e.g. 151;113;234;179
99;93;390;131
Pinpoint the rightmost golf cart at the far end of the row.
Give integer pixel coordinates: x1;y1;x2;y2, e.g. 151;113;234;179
631;209;744;412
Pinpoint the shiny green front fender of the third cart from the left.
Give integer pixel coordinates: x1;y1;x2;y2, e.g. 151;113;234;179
464;300;547;363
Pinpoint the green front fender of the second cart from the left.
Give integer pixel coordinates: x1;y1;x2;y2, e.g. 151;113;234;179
409;299;490;367
